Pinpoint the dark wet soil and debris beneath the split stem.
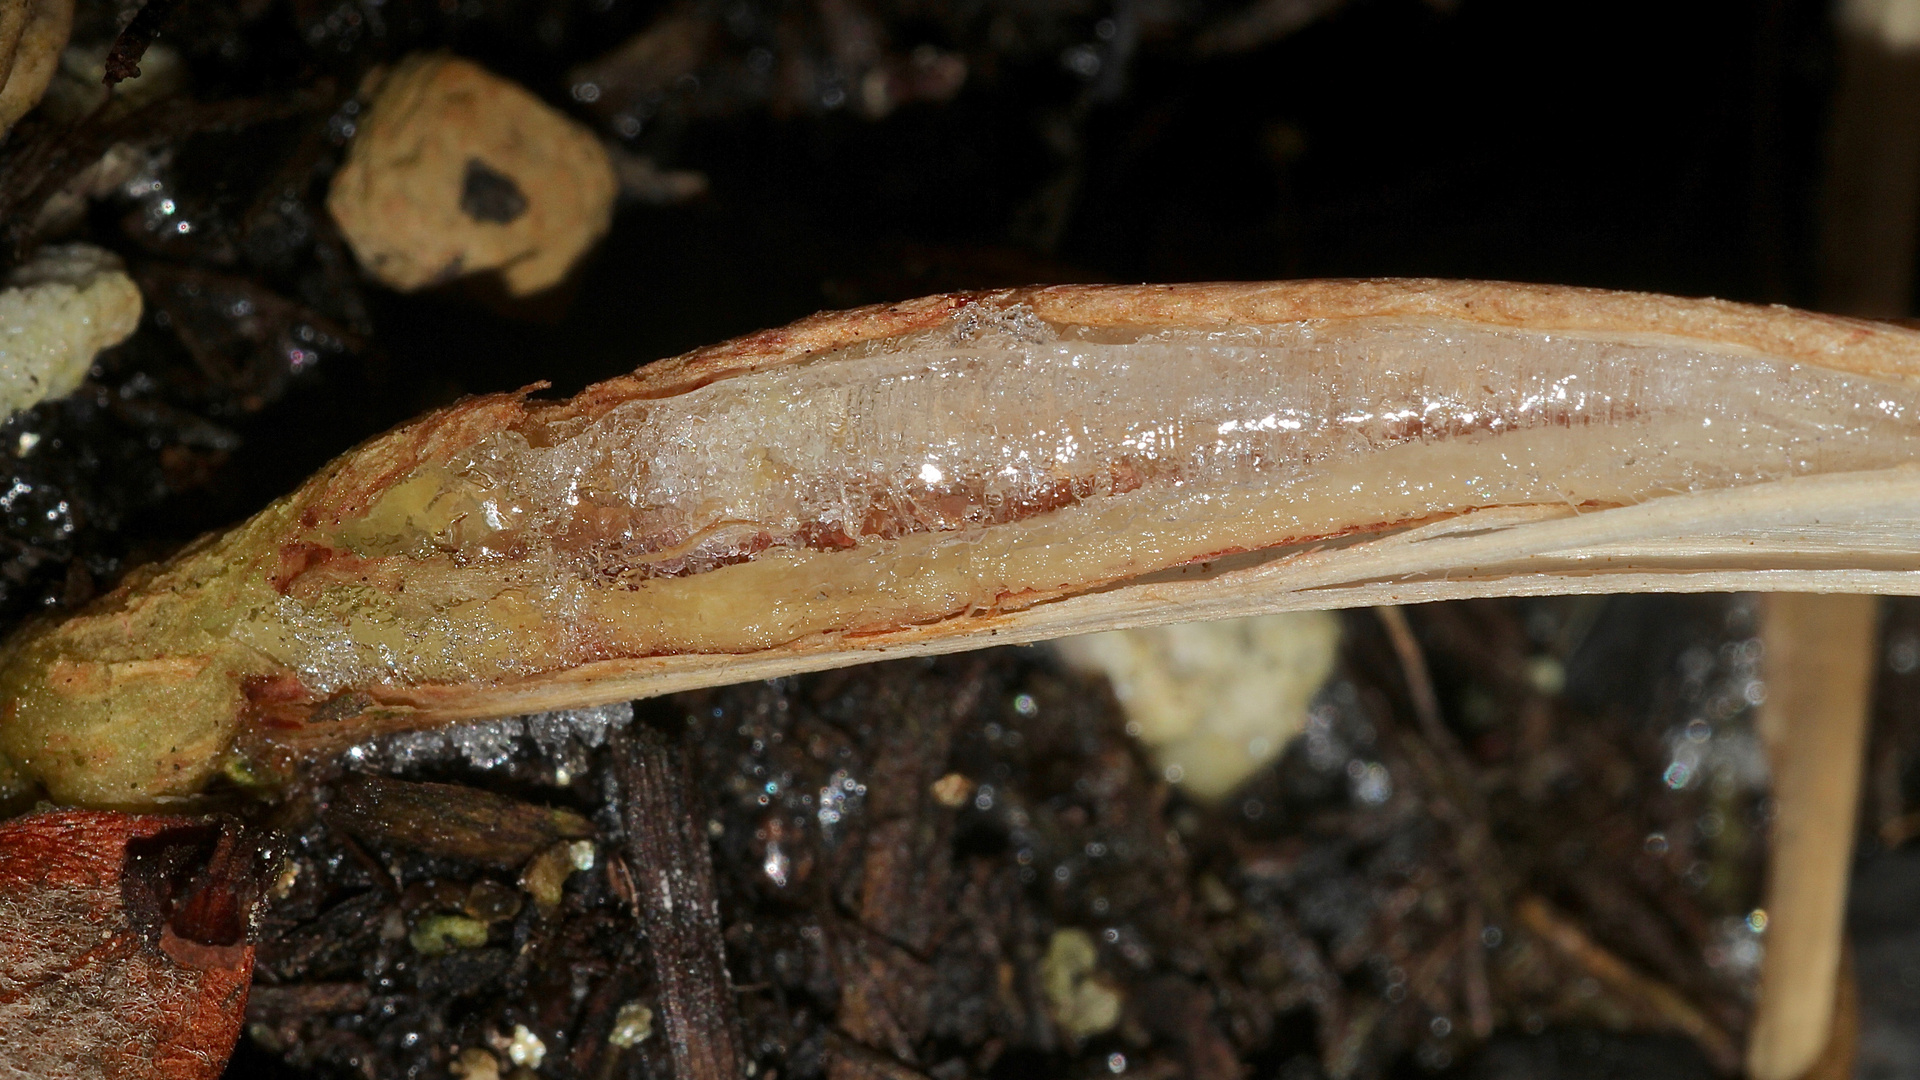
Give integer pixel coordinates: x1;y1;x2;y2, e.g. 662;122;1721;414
232;598;1761;1078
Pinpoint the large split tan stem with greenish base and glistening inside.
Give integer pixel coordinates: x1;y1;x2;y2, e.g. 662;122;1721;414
11;281;1920;805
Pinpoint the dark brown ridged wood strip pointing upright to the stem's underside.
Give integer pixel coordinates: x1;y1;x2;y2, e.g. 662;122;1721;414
612;723;741;1080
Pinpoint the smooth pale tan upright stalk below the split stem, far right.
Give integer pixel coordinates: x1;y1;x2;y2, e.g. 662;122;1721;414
1747;594;1878;1080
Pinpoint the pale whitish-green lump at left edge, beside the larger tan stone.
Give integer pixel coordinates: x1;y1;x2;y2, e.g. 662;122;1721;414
0;244;140;419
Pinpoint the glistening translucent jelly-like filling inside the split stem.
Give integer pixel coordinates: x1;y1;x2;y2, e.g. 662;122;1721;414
382;321;1920;582
